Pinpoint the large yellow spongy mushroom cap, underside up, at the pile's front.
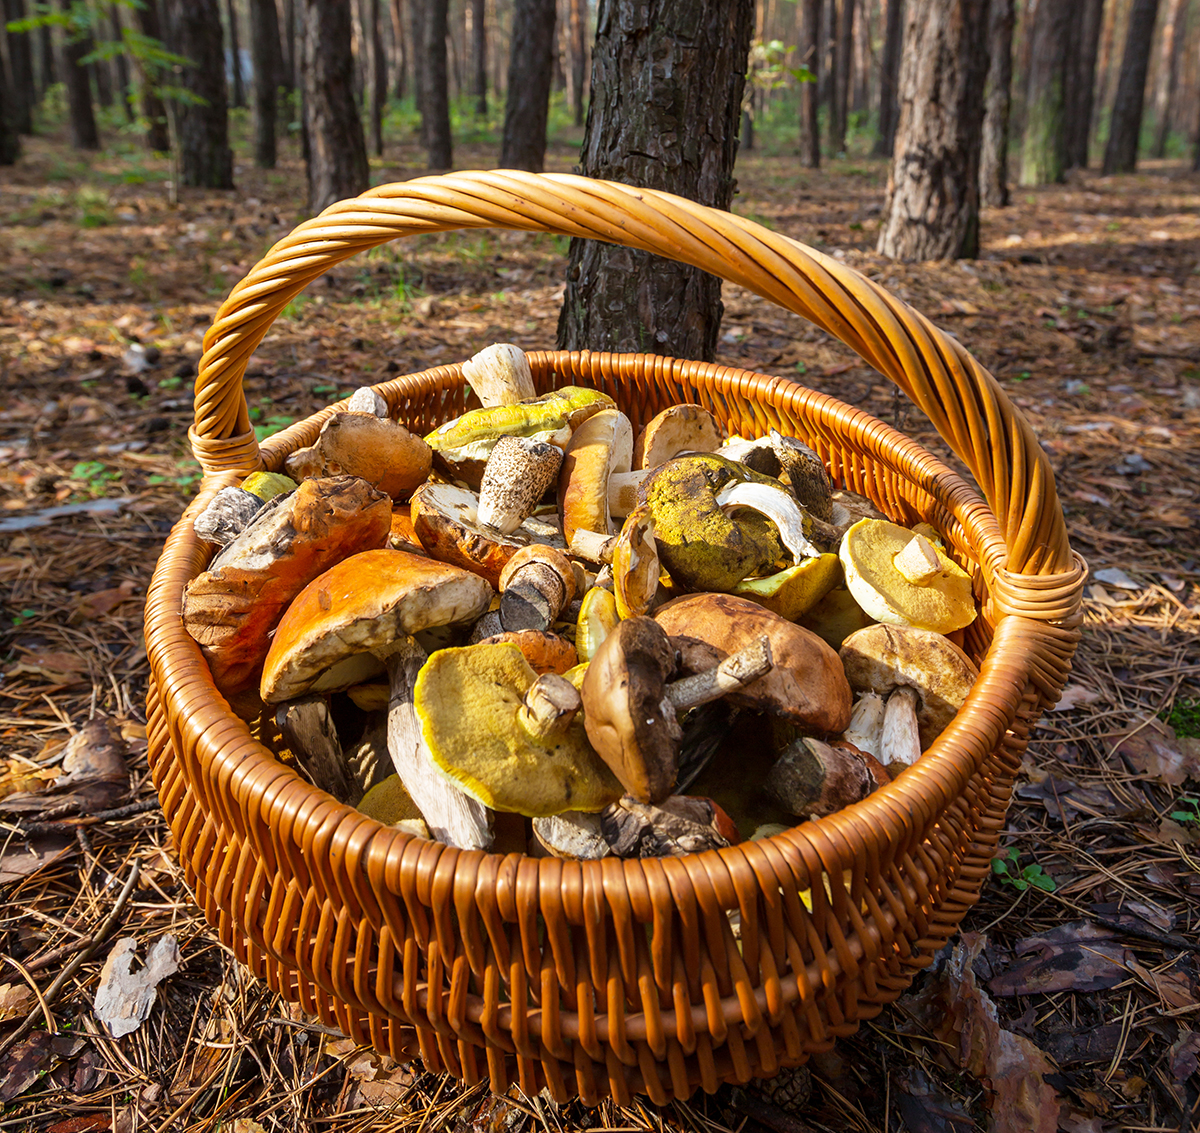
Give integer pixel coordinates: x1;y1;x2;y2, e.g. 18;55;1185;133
413;643;623;817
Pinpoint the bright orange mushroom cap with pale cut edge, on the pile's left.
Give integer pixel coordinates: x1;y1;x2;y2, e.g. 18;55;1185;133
260;550;492;703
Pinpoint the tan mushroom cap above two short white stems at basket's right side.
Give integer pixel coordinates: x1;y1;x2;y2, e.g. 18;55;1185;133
841;624;979;751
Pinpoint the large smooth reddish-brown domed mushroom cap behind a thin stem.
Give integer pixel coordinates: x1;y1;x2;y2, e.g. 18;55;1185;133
657;594;851;733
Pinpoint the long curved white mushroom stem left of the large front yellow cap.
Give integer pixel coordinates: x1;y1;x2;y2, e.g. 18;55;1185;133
384;637;492;850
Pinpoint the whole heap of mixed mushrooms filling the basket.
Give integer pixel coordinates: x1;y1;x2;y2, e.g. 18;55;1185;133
182;344;977;858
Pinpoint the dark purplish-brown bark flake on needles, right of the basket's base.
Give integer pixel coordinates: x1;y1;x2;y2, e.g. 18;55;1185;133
988;921;1133;996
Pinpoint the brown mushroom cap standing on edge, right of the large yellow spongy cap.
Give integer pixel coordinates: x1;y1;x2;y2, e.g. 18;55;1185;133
580;618;683;802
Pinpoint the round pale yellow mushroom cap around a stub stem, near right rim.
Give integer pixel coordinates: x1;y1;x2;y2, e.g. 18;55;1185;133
839;518;976;634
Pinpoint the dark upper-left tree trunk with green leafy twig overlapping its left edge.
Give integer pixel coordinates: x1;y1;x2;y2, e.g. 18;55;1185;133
170;0;233;188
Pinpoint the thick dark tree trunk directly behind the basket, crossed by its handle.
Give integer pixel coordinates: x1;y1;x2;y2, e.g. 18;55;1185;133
558;0;754;360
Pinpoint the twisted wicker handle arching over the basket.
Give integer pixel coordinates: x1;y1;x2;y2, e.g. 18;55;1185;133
191;172;1078;580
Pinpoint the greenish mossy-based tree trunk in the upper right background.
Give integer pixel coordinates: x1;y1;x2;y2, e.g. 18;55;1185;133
1021;0;1074;185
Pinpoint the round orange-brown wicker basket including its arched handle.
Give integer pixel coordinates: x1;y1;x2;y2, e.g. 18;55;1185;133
145;173;1085;1103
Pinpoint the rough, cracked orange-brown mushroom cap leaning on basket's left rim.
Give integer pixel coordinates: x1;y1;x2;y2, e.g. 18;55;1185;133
184;476;391;697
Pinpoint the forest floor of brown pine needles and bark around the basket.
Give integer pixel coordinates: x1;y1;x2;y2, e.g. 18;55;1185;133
0;123;1200;1133
